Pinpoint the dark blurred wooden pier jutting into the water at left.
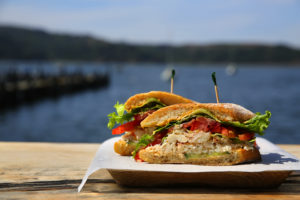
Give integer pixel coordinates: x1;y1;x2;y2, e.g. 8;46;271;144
0;71;109;109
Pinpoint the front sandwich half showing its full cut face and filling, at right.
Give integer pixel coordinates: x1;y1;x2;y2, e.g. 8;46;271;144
133;103;271;165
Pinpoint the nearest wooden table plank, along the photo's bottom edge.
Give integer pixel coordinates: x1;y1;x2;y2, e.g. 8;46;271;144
0;181;300;199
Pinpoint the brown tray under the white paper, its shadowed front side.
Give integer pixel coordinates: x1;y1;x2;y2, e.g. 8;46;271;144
108;169;292;188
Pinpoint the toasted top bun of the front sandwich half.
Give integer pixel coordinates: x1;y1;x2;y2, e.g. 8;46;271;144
141;103;255;128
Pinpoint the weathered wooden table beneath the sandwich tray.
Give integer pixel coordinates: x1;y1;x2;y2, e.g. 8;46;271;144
0;142;300;200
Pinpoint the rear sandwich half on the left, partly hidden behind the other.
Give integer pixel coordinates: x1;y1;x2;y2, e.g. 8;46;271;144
107;91;193;156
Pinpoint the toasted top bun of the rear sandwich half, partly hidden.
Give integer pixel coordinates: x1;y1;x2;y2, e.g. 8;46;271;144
125;91;193;112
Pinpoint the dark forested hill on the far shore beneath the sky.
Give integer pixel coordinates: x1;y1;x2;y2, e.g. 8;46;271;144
0;26;300;63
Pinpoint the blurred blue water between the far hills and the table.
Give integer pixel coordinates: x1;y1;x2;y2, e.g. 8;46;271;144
0;63;300;144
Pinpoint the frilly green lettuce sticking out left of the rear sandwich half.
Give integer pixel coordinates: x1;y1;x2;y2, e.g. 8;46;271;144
107;102;133;129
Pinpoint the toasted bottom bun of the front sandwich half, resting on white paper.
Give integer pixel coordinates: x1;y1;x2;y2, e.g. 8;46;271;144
139;147;261;166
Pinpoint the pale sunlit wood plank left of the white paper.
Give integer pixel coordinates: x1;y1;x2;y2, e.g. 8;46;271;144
0;142;99;183
